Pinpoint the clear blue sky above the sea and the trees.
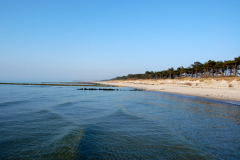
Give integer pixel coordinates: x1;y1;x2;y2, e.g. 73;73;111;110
0;0;240;82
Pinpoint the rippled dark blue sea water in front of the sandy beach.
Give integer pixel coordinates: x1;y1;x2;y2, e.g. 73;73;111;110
0;85;240;159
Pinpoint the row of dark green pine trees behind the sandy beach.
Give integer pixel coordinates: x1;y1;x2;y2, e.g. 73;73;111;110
112;56;240;80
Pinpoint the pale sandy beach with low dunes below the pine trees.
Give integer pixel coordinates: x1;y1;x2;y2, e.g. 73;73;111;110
96;77;240;102
